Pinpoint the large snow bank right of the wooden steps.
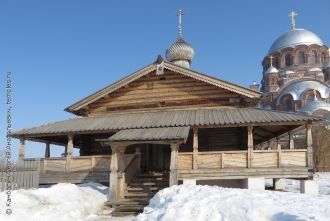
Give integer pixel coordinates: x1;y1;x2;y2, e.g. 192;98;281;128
134;181;330;221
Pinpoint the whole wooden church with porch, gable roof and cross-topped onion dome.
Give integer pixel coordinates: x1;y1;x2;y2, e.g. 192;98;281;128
12;11;322;215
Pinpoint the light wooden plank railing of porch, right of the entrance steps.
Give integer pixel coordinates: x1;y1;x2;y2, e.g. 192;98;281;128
178;149;307;170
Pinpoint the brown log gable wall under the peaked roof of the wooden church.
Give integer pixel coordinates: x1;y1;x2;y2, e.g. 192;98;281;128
89;70;239;115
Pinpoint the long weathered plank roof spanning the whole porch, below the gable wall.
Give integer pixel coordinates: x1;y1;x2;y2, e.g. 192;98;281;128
12;107;322;137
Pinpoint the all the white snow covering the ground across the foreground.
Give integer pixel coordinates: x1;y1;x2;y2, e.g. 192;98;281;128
0;173;330;221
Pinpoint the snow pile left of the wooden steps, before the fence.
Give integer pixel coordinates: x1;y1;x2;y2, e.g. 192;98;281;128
0;183;107;221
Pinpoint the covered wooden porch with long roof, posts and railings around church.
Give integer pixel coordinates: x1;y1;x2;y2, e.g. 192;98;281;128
13;108;322;204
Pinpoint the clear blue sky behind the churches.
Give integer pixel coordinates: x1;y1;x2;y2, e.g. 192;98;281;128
0;0;330;158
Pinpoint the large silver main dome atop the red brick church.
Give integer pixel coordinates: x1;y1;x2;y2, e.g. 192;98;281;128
268;29;324;54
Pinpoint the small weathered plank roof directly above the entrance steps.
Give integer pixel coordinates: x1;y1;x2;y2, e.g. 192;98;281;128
108;127;190;142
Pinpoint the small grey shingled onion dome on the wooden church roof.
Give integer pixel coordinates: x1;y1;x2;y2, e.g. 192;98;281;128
166;37;195;67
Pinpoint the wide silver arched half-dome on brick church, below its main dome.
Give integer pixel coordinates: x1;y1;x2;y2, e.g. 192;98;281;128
276;80;330;105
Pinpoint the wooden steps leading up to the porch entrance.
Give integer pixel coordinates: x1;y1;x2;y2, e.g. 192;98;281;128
111;173;168;217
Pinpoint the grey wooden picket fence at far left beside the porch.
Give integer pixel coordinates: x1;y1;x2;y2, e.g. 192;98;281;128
0;160;40;191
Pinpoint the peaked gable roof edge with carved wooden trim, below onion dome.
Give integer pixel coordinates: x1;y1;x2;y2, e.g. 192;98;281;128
65;59;262;113
